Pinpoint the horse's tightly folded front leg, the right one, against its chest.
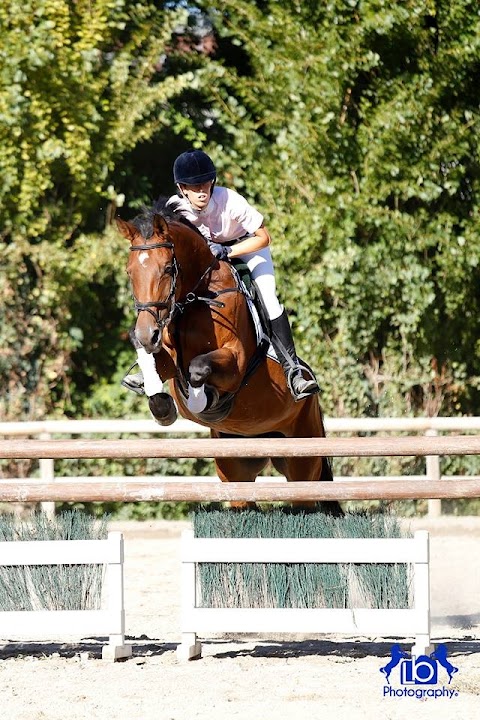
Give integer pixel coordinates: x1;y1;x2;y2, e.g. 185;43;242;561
187;348;242;413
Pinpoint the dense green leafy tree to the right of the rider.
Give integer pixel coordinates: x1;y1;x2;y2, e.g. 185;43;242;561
190;0;480;415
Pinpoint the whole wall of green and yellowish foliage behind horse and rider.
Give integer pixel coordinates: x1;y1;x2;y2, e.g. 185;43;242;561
0;0;480;506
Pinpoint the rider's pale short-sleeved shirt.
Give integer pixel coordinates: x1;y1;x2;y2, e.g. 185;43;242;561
168;185;263;243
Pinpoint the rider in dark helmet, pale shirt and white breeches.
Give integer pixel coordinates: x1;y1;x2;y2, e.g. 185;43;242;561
125;150;319;400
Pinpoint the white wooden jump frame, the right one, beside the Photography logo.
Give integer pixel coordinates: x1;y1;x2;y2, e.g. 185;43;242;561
177;530;430;660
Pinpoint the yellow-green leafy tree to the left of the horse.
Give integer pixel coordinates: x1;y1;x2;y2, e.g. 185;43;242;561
0;0;204;418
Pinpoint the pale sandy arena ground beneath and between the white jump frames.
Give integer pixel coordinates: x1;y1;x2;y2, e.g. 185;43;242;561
0;518;480;720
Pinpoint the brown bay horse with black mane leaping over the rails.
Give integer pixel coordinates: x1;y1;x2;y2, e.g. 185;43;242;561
117;198;342;514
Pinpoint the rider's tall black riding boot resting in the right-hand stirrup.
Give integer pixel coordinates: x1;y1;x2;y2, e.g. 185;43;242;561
270;310;320;400
